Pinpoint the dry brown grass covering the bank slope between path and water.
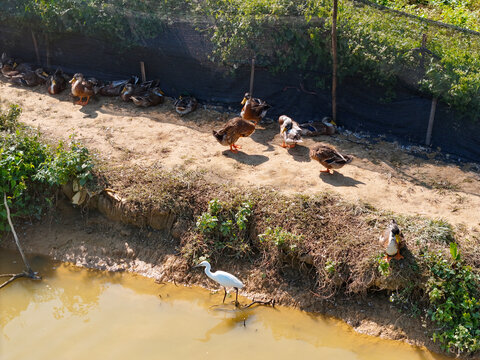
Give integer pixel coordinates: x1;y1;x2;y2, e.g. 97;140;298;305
89;164;480;298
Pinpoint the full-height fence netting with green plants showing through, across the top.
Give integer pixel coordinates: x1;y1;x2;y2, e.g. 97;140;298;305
0;0;480;160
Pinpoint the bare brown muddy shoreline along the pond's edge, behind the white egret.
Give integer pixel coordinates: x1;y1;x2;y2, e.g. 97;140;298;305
1;197;456;353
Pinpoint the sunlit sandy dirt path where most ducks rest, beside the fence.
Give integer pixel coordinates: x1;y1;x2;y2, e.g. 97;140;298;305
0;80;480;231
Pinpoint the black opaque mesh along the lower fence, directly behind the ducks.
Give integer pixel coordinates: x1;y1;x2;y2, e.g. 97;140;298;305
0;2;480;161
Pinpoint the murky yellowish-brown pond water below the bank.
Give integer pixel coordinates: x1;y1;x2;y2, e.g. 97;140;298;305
0;249;446;360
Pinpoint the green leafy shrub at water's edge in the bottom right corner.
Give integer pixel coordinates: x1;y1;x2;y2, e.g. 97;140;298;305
425;243;480;353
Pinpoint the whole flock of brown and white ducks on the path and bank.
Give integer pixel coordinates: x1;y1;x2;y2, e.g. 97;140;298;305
0;53;404;261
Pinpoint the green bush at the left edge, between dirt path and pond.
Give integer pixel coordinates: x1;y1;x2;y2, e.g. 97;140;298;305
0;107;93;230
